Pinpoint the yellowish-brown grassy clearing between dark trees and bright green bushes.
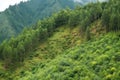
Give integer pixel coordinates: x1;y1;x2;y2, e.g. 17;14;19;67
0;25;82;80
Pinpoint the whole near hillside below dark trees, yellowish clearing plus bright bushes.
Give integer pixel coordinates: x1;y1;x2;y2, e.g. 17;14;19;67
1;21;120;80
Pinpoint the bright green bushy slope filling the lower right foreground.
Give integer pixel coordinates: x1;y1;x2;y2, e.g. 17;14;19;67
15;33;120;80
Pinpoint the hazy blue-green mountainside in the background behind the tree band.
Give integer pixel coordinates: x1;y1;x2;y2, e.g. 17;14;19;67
0;0;75;41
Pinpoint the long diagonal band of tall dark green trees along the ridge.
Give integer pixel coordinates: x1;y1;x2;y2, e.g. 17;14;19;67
0;0;120;68
